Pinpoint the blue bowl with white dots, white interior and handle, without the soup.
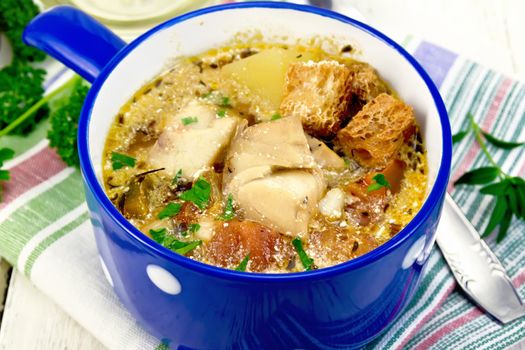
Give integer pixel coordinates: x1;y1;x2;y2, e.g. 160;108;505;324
24;2;451;349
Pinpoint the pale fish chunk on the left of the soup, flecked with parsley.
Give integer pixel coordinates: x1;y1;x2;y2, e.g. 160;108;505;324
148;101;242;180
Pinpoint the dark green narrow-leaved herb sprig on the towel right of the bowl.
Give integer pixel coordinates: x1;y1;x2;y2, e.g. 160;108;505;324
452;113;525;242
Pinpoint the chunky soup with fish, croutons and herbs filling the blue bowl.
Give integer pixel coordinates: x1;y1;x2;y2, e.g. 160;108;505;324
103;43;427;273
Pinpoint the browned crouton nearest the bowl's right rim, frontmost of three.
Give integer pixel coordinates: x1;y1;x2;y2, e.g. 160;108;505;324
337;94;416;168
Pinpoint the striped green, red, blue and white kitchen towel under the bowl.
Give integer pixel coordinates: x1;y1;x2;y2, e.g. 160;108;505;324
0;39;525;349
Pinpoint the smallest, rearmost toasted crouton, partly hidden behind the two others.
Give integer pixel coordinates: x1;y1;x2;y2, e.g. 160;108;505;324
348;61;389;104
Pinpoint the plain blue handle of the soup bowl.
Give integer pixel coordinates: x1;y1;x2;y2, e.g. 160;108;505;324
22;6;126;83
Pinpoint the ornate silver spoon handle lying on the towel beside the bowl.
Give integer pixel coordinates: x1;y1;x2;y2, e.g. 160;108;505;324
437;194;525;323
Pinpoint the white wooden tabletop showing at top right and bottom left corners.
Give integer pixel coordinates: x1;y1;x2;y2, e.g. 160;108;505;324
0;0;525;350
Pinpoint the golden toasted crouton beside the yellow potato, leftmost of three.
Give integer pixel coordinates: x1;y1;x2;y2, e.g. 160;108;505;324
280;61;350;137
